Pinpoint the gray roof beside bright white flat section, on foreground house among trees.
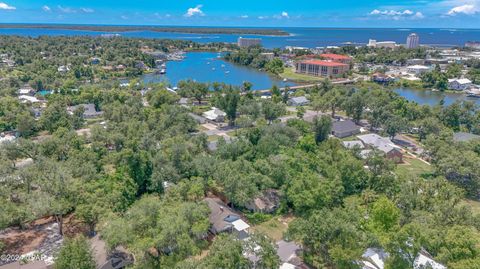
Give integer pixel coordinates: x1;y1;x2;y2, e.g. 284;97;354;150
204;197;240;233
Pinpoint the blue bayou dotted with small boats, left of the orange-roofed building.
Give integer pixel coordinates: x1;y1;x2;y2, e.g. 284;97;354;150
143;52;294;90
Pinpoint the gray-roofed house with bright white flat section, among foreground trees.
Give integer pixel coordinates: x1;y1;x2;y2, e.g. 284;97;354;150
204;197;250;239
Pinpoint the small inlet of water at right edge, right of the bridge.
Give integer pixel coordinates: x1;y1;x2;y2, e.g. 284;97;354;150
394;88;480;106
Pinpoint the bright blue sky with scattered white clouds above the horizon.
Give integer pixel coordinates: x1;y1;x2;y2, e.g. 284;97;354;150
0;0;480;28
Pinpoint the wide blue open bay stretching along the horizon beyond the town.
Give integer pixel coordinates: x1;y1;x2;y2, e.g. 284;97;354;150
0;28;480;48
